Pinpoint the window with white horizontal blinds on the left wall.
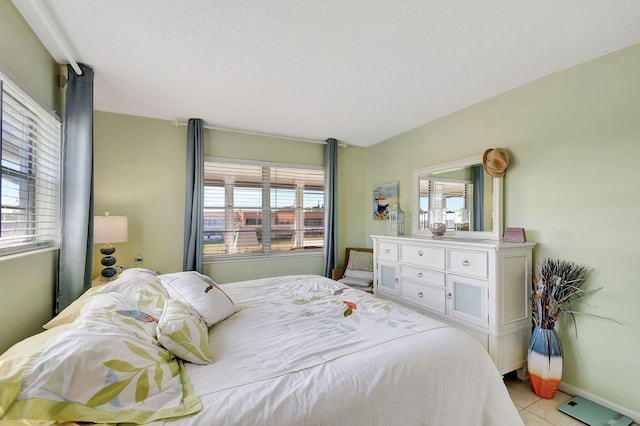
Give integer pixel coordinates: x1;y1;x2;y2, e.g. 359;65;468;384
0;73;61;255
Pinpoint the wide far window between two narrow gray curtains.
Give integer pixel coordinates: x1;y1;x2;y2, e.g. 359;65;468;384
204;158;324;258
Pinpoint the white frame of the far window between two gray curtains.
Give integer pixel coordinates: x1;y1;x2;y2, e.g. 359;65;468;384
203;156;326;262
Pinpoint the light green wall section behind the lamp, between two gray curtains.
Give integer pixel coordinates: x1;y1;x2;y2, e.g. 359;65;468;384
93;111;186;276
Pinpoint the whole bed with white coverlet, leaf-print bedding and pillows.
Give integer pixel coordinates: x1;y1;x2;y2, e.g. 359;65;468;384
0;268;522;426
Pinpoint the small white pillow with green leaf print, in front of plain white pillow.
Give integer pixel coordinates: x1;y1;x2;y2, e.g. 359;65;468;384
158;299;213;364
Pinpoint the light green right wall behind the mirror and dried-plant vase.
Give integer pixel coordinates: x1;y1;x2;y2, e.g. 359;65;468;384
362;44;640;413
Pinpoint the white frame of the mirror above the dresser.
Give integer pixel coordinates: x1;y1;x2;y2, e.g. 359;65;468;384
411;155;503;240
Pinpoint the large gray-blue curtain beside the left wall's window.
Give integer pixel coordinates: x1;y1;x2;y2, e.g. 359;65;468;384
54;65;93;314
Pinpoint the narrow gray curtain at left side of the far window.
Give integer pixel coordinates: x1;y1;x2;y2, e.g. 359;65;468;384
182;118;204;273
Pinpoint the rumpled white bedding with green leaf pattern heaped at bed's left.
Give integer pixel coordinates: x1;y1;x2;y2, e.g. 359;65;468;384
0;270;215;423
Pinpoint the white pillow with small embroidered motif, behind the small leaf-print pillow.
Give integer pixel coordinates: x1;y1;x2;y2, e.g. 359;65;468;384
159;271;236;327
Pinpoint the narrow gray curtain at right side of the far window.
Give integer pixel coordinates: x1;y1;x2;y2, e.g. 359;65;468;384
324;138;338;278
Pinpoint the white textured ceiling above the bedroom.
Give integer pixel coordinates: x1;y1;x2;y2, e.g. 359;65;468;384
13;0;640;146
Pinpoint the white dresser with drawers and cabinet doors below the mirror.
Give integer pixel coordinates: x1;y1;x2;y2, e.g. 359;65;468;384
371;235;535;374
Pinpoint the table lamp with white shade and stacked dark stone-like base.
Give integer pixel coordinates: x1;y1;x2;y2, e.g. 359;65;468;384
93;212;127;281
